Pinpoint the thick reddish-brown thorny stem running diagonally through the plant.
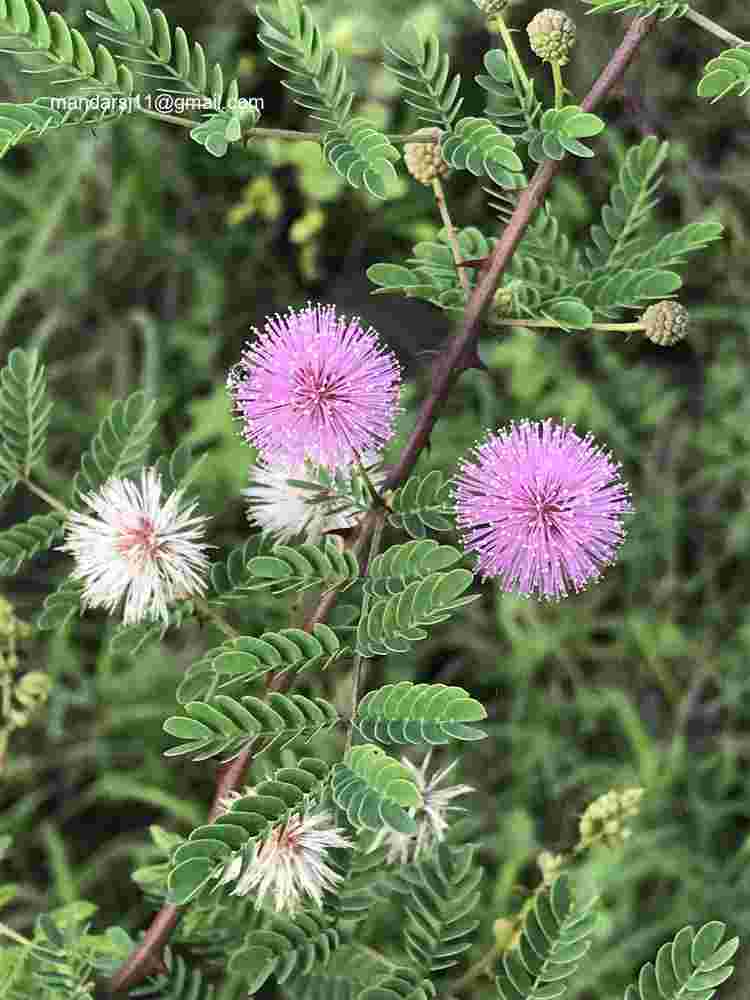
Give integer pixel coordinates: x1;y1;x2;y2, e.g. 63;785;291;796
110;9;656;993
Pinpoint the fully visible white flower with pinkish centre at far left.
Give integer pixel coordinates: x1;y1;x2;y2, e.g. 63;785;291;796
61;469;208;625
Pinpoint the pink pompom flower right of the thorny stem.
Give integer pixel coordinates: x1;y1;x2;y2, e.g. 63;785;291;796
455;420;632;599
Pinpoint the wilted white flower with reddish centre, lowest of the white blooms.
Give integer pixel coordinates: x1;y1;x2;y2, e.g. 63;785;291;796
219;812;353;913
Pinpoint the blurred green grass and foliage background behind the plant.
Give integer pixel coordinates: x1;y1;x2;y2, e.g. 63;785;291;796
0;0;750;1000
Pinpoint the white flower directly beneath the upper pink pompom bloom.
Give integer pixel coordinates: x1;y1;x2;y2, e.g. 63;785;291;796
242;455;385;542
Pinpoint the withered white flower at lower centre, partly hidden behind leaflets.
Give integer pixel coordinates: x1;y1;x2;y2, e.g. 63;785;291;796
370;750;474;865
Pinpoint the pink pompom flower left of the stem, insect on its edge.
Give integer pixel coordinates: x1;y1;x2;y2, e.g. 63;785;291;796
228;304;401;466
